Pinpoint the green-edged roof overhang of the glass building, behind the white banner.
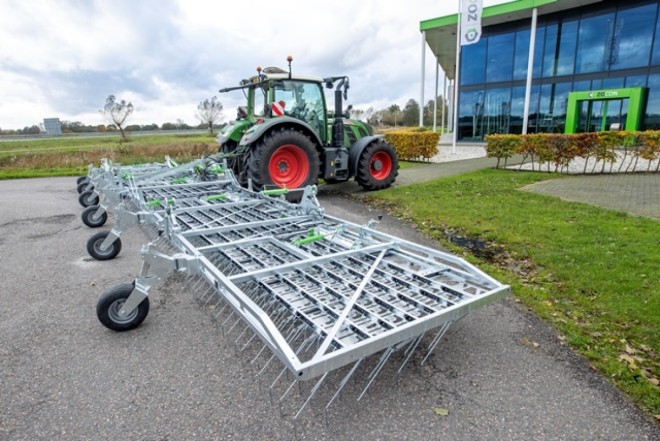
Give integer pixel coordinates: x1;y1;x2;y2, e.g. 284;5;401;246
419;0;601;80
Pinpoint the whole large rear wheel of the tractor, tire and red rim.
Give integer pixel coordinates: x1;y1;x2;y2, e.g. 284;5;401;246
247;128;319;190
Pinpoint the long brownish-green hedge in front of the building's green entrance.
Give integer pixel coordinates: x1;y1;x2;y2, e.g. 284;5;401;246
486;130;660;173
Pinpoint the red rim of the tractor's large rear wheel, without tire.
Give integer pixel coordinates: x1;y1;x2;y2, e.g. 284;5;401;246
268;144;309;188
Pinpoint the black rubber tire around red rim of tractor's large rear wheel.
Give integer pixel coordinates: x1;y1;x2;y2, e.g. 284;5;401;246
247;127;320;190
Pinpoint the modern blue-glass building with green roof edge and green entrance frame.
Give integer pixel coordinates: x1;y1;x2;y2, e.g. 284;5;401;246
420;0;660;141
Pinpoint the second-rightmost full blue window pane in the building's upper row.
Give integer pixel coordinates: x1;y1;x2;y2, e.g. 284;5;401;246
575;13;614;73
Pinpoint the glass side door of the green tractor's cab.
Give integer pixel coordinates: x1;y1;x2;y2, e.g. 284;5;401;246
271;80;327;143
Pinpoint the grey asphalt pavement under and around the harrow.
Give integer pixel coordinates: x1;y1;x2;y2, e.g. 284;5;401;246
0;178;660;441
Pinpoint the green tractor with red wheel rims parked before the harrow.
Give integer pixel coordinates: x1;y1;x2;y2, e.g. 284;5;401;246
218;57;399;190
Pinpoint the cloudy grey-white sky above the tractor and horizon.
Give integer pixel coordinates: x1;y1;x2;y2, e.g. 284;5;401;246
0;0;504;129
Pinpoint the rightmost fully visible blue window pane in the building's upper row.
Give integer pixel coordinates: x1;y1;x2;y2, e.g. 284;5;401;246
608;4;657;69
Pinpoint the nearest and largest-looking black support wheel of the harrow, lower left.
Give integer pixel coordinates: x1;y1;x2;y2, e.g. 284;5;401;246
96;283;149;332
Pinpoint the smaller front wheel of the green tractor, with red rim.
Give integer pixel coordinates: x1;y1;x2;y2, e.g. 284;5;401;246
355;140;399;190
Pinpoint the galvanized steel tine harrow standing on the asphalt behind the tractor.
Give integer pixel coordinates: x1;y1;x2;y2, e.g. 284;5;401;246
85;161;509;420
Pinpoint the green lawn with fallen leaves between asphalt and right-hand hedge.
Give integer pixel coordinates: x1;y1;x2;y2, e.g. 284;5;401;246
370;170;660;415
